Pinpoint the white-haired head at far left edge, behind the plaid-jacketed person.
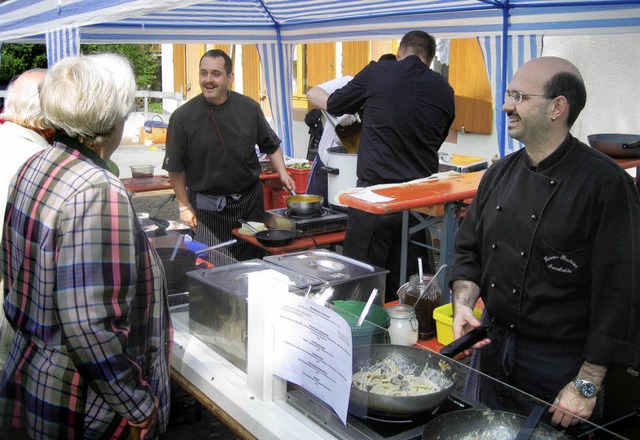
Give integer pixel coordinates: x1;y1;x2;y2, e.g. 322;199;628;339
2;69;49;130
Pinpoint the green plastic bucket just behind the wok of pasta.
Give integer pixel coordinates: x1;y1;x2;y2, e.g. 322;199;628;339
333;300;389;347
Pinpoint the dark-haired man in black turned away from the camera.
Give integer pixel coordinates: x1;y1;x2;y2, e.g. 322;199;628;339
327;30;455;301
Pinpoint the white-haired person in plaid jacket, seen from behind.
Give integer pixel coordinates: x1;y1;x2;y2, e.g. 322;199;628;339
0;54;171;439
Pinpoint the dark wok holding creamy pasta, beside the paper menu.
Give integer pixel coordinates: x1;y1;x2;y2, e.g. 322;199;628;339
349;344;458;419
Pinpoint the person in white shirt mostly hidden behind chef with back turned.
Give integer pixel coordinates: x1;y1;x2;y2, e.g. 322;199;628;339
307;53;396;205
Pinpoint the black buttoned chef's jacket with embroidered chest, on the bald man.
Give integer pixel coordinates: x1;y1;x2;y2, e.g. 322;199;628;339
450;135;640;368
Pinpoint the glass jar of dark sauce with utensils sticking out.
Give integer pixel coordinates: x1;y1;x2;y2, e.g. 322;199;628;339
398;274;442;339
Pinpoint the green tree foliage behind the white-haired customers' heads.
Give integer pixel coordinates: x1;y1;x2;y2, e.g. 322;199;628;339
0;43;162;90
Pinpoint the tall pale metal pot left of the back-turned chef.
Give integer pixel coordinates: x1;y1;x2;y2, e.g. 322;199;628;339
321;147;358;209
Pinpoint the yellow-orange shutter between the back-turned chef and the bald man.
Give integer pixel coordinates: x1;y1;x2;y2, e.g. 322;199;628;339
449;38;493;134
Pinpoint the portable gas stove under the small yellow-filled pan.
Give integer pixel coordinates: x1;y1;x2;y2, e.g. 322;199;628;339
264;208;347;235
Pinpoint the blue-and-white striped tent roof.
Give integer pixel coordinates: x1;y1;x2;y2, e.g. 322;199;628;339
0;0;640;43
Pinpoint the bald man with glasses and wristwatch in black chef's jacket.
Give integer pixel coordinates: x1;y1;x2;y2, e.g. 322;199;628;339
450;57;640;427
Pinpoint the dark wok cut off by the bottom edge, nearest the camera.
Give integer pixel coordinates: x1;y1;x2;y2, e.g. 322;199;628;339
422;409;568;440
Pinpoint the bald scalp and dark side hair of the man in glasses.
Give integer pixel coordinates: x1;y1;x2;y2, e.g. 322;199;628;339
513;57;587;128
